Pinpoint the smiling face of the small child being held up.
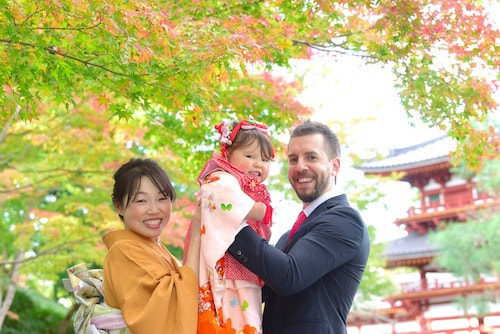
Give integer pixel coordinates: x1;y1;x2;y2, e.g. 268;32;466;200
228;140;271;182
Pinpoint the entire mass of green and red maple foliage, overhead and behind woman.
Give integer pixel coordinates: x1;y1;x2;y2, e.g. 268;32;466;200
0;0;500;327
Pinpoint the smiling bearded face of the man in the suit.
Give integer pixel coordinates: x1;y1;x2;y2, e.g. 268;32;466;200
288;133;340;206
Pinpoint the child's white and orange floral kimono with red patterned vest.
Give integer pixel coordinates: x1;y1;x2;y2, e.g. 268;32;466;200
191;155;272;334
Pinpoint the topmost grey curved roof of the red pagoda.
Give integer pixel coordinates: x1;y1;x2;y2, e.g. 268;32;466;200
356;136;454;174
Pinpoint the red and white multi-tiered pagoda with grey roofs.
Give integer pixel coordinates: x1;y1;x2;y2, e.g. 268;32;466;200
348;136;500;334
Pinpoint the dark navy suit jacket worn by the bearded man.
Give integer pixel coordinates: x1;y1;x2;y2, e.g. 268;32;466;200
229;195;370;334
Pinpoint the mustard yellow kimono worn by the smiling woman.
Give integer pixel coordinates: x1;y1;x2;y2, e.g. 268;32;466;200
103;230;198;334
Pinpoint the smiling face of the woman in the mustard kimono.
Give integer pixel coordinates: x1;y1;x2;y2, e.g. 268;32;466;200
116;176;172;242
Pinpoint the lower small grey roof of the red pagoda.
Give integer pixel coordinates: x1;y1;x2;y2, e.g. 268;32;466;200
383;233;438;267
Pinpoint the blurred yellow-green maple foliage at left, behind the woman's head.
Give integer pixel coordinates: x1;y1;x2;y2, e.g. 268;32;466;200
0;105;126;327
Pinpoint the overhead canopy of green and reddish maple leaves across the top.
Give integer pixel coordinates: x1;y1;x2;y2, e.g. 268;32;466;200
0;0;500;166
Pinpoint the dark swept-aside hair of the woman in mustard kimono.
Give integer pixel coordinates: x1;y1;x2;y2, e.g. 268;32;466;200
111;158;175;218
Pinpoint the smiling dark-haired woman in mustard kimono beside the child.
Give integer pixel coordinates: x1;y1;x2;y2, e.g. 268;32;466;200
103;159;200;334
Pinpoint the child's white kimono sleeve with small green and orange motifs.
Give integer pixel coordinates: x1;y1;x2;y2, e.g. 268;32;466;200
201;172;255;268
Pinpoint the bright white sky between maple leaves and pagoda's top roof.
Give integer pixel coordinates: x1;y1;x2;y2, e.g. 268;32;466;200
299;57;446;149
